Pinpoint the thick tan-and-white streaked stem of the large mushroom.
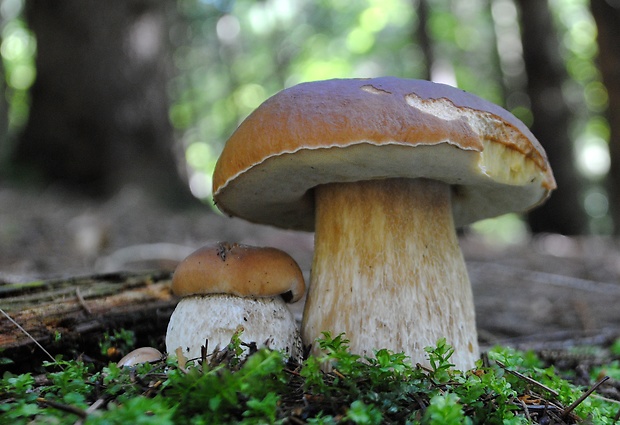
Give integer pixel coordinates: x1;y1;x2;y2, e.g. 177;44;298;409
302;179;479;370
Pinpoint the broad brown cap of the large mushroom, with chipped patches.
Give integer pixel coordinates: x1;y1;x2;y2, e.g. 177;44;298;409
213;77;556;231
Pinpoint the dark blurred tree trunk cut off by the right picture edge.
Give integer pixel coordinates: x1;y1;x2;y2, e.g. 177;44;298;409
590;0;620;235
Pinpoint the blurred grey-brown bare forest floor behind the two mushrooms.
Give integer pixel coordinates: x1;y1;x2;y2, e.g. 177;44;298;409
0;181;620;350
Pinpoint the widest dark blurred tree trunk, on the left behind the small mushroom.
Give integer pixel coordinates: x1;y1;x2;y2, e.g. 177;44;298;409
14;0;196;203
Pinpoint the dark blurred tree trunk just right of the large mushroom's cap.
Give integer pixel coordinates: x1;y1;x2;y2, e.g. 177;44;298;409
516;0;587;235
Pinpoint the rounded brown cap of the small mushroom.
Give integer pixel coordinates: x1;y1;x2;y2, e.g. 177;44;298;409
172;242;306;302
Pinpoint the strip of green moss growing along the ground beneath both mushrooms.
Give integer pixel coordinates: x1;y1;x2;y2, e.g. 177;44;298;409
0;333;617;425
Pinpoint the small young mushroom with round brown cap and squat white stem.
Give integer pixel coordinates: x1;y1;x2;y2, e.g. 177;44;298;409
166;242;305;359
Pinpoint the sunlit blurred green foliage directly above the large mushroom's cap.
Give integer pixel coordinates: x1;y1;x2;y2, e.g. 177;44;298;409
170;0;502;198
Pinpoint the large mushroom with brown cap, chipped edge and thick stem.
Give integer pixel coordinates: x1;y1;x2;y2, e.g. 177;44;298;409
213;77;555;369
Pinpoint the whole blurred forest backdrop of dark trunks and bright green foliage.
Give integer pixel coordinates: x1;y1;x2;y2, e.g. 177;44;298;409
0;0;620;235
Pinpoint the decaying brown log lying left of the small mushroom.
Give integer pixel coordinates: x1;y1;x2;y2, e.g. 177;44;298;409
0;272;177;370
